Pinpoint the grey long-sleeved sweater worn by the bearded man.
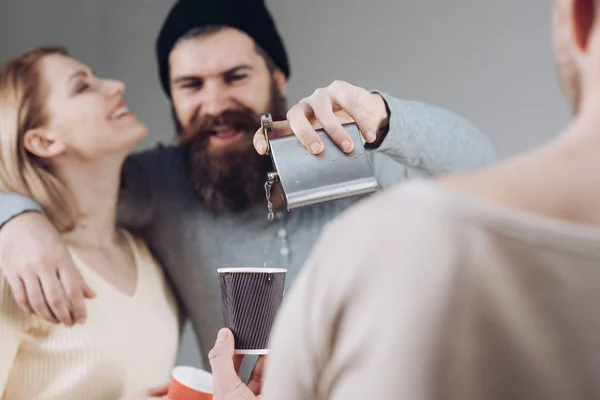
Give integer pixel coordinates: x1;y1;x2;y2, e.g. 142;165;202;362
0;93;495;368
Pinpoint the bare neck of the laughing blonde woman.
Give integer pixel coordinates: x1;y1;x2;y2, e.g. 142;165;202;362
57;155;122;248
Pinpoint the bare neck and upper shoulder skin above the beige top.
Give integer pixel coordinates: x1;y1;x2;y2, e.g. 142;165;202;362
441;108;600;226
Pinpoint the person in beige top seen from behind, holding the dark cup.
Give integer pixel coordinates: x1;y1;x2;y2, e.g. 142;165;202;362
206;0;600;400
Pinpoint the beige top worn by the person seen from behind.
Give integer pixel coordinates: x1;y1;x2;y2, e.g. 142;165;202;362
264;182;600;399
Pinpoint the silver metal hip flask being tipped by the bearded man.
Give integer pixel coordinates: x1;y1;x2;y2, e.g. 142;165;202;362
261;114;377;211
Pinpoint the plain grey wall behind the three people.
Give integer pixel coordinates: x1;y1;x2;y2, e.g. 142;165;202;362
0;0;570;365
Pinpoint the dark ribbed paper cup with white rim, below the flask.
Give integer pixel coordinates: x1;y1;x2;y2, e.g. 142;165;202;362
218;268;287;354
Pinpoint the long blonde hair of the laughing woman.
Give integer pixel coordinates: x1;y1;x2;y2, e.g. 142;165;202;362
0;47;75;232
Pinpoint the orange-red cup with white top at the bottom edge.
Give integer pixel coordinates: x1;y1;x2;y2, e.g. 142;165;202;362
167;365;213;400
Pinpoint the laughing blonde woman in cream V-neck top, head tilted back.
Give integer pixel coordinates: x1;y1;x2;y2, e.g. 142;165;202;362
0;48;180;400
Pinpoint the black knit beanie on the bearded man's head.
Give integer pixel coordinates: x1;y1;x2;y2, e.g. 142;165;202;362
156;0;290;97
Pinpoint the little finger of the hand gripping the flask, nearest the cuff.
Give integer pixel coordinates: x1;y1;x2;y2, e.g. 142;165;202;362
330;81;379;143
